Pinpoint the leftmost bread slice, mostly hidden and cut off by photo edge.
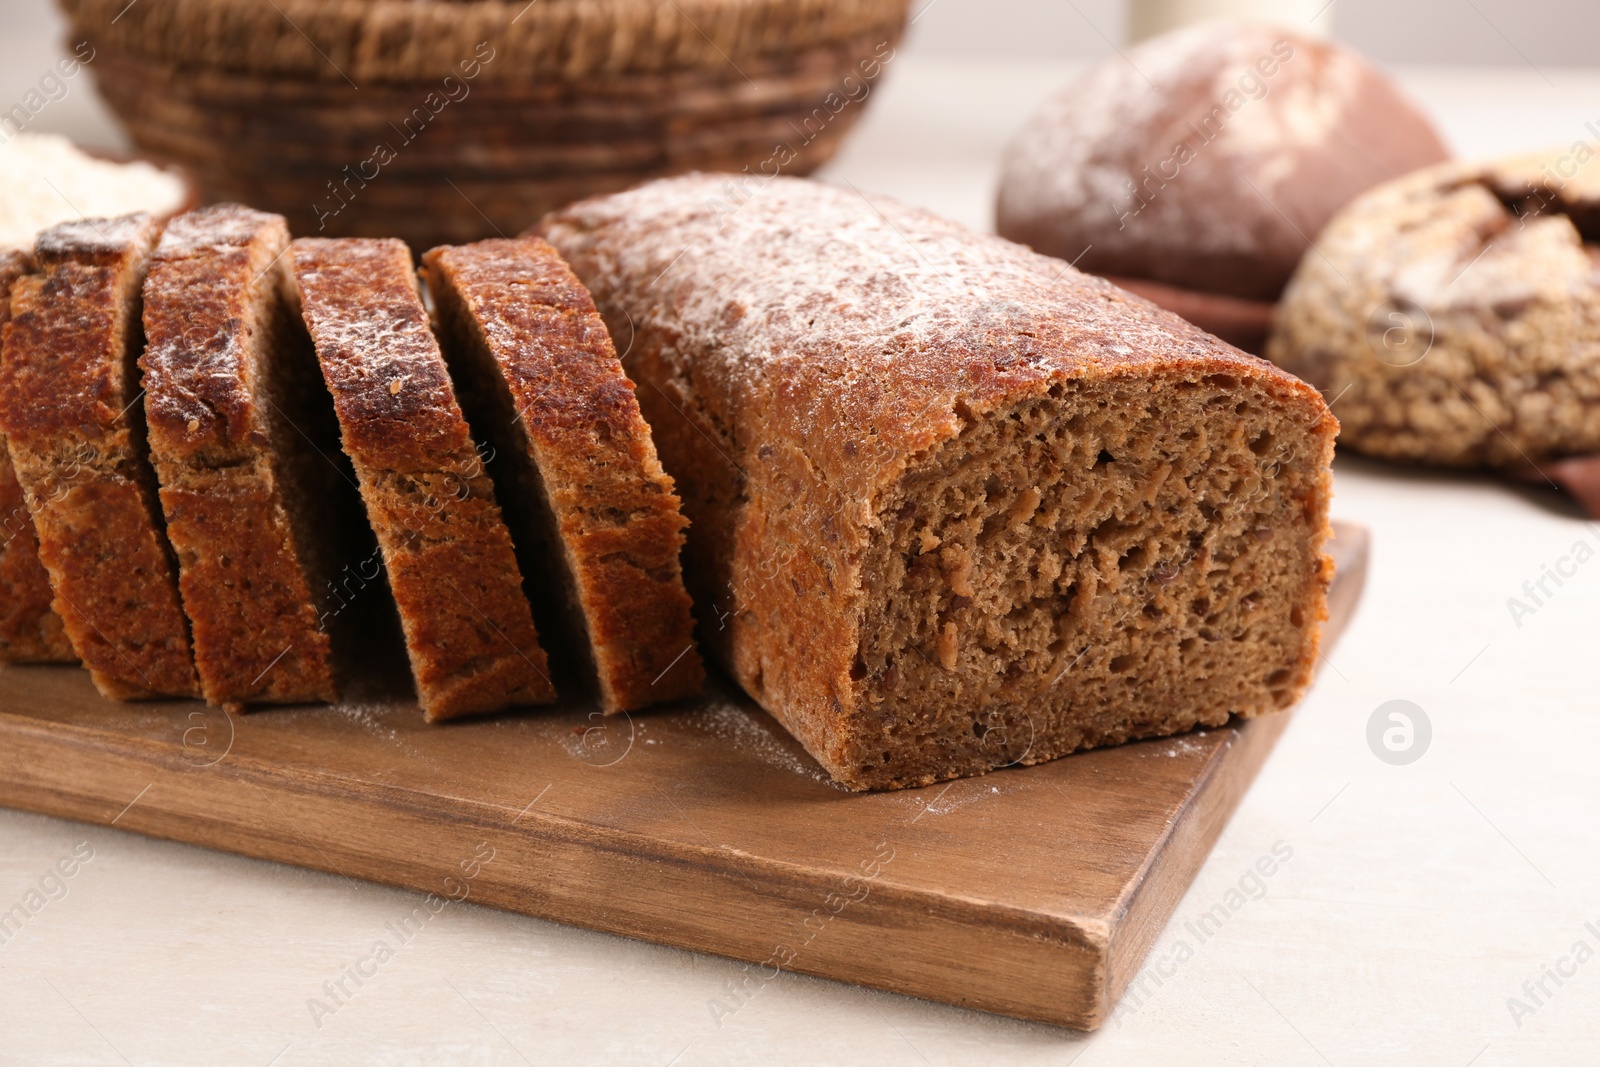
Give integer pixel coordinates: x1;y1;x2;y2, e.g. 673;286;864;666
0;251;78;664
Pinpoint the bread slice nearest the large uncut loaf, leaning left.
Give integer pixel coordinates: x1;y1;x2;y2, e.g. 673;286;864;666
422;238;706;712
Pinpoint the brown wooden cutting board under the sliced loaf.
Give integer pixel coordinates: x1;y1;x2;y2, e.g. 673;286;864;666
0;525;1366;1029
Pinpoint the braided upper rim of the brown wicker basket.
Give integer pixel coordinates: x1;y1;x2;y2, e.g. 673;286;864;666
58;0;910;85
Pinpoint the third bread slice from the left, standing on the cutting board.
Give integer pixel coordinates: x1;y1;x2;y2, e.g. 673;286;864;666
139;205;363;709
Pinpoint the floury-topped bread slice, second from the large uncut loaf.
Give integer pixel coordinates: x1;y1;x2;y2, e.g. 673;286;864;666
290;238;555;720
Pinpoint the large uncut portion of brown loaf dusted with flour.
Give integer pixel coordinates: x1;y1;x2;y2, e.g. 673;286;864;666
542;176;1336;789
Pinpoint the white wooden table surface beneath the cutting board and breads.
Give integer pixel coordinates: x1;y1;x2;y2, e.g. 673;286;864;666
0;35;1600;1067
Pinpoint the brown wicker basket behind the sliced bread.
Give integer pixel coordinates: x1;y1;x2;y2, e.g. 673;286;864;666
62;0;909;250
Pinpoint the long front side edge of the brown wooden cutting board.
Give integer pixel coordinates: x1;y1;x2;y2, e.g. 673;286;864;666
0;715;1109;1029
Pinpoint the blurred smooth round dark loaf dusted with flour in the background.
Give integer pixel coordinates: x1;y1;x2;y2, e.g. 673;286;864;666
997;22;1450;301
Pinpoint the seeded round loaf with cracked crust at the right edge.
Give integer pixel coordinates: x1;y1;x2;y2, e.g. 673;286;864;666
1267;142;1600;483
